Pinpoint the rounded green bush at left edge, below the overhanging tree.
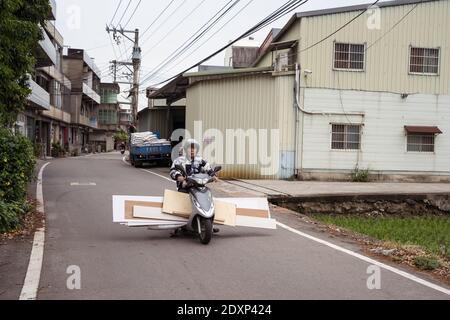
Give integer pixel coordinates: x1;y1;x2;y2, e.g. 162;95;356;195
0;128;36;204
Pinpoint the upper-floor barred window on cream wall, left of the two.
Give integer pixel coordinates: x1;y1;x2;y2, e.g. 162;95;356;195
334;43;365;71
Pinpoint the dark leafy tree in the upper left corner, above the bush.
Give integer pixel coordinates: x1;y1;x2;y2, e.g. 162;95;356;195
0;0;51;127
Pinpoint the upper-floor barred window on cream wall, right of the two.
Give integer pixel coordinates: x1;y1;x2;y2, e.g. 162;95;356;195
409;47;439;75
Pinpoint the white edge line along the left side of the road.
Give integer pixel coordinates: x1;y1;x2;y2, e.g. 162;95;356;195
19;162;50;300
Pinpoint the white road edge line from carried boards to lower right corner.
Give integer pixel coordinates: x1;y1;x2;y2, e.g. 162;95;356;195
277;222;450;296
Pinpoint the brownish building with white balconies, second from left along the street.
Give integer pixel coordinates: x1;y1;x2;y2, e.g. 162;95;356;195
63;49;101;153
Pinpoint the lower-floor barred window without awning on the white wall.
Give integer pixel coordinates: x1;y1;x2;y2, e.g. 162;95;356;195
331;124;362;150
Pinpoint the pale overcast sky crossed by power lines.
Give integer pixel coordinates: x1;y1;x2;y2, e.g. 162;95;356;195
56;0;386;108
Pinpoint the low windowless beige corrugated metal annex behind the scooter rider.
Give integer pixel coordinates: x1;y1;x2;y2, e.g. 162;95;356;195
185;68;295;179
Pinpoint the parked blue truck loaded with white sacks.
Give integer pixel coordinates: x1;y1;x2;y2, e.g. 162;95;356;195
130;132;172;168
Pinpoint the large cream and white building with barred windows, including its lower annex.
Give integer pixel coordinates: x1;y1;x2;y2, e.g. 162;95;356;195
151;0;450;181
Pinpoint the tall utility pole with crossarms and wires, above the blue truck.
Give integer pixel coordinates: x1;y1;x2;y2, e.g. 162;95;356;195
106;26;141;128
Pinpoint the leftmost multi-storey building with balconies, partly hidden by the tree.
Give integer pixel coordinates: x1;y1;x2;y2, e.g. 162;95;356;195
17;1;71;156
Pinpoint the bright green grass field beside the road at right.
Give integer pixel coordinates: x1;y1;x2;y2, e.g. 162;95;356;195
313;215;450;259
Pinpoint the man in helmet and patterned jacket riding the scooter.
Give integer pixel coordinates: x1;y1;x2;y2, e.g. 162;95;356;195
170;139;219;233
